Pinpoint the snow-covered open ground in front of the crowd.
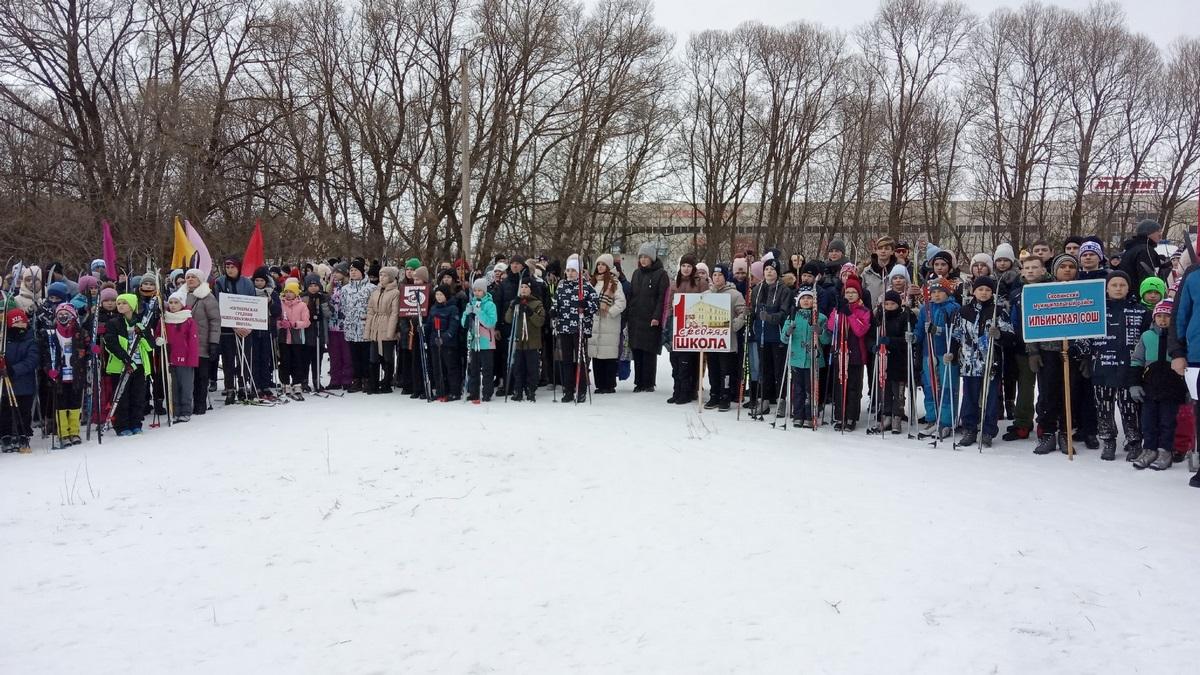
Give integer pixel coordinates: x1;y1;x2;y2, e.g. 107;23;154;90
0;362;1200;674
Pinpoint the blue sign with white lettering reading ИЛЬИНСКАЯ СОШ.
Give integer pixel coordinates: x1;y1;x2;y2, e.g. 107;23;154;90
1021;279;1106;342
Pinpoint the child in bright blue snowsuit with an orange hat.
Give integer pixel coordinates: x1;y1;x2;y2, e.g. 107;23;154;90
913;279;959;438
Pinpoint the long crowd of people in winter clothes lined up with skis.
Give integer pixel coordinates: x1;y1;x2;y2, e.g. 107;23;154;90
0;221;1200;486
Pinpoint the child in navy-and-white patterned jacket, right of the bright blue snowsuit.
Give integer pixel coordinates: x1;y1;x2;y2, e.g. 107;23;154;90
947;276;1013;448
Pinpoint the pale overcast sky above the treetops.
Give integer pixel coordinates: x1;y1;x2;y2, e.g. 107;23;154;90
654;0;1200;48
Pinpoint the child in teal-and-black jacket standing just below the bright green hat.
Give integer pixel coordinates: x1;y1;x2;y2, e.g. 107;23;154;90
1129;300;1188;471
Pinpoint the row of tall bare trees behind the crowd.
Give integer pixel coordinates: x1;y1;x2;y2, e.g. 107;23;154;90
0;0;1200;266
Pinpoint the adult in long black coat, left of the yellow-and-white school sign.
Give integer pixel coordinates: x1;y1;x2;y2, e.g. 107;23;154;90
625;243;671;392
